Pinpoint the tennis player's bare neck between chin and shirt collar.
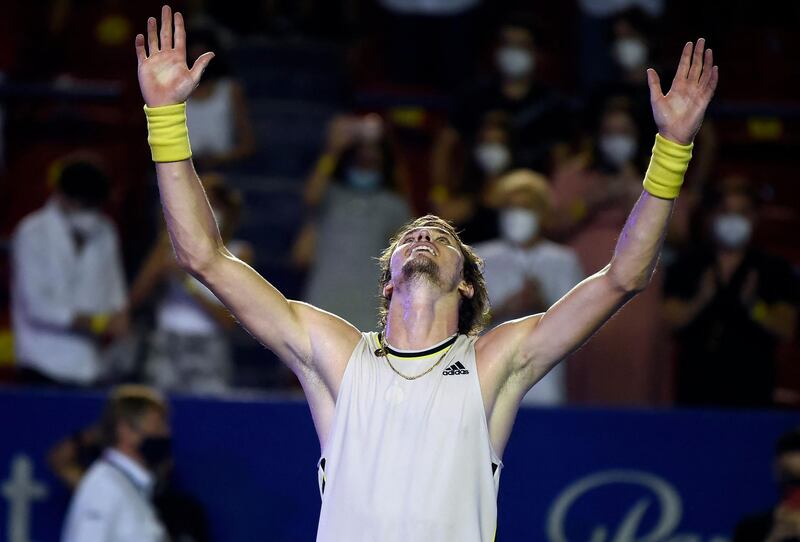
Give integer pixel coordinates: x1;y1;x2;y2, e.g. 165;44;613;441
386;285;460;350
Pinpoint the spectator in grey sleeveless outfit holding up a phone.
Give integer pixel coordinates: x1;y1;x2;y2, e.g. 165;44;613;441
293;115;410;330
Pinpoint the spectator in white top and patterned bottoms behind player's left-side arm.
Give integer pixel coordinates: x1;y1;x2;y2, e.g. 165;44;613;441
131;174;252;393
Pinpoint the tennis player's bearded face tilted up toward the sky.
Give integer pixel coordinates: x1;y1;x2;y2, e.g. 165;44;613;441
389;226;464;298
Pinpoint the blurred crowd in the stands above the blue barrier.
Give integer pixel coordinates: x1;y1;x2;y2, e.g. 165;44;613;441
0;0;800;408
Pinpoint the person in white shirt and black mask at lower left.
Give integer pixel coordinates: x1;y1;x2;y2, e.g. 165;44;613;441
61;385;171;542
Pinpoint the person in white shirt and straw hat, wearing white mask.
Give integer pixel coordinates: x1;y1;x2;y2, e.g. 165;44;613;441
475;169;585;405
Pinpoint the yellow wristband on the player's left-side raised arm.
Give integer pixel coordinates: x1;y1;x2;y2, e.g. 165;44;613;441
144;103;192;162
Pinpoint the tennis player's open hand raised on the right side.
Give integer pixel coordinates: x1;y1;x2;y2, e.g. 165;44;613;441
647;38;719;145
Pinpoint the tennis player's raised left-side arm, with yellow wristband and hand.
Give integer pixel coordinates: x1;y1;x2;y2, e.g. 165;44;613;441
136;6;359;384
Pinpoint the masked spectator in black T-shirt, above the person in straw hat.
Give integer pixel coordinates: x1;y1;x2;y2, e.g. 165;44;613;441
431;21;571;189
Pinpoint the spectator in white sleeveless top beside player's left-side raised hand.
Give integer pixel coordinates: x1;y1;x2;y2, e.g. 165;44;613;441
186;29;256;172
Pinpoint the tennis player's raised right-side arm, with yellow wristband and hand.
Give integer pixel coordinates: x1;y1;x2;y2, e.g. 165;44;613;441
484;39;717;394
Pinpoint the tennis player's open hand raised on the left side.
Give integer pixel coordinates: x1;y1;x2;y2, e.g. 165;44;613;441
136;6;214;107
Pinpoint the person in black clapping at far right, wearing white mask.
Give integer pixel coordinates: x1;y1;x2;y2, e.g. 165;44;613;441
664;181;799;407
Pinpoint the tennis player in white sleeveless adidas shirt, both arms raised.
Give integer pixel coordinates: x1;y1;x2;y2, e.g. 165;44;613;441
136;6;718;542
